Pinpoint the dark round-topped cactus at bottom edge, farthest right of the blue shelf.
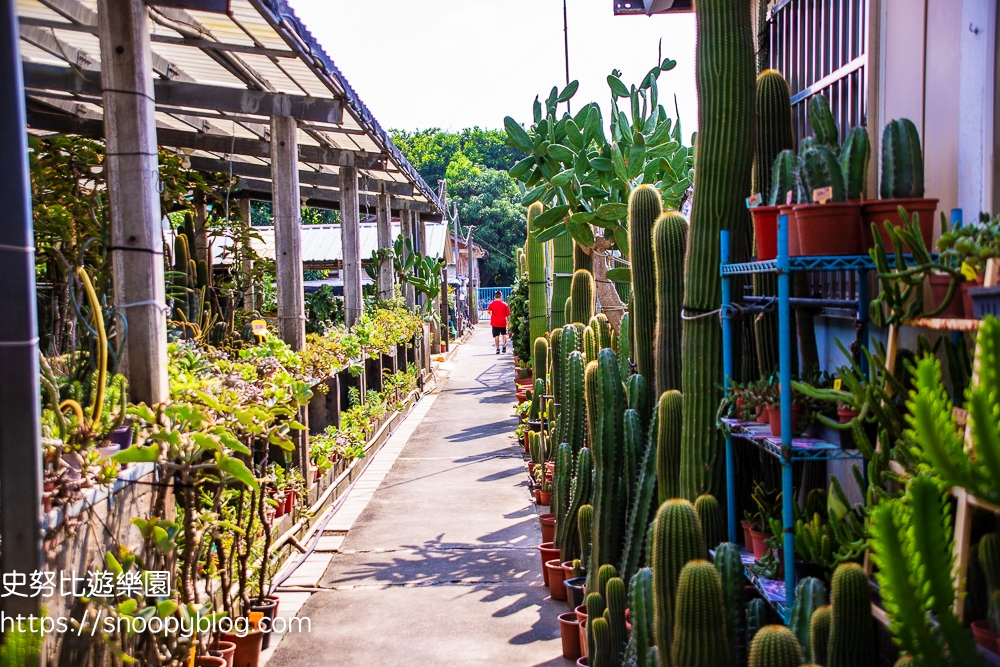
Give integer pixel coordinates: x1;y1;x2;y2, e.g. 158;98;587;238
826;563;875;667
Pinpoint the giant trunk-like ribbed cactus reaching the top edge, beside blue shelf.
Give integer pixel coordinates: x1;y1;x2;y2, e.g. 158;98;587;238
684;0;757;500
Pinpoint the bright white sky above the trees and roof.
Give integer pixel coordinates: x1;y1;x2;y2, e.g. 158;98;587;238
289;0;697;138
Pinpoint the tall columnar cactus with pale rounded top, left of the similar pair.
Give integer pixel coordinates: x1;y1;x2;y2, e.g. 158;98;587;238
628;185;664;385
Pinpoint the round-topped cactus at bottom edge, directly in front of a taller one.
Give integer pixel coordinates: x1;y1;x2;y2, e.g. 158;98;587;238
670;560;729;667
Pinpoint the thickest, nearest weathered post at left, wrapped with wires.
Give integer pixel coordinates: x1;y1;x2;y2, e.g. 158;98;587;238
97;0;169;405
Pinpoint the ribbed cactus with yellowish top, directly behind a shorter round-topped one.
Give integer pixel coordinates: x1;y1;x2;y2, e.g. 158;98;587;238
649;499;707;659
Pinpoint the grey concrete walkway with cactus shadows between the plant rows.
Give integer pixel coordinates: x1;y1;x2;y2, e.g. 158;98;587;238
268;325;570;667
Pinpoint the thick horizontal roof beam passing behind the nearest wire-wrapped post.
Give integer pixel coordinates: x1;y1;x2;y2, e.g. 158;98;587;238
22;63;344;125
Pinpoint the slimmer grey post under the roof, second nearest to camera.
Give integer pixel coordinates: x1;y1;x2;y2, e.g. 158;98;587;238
271;116;306;351
